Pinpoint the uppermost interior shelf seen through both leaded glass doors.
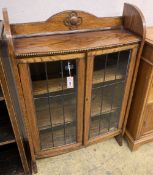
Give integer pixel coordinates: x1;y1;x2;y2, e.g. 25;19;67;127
32;68;123;95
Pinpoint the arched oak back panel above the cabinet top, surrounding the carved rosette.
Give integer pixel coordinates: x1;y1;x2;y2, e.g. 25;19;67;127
11;10;122;35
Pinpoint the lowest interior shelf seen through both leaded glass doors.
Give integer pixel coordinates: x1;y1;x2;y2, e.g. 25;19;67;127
40;110;117;149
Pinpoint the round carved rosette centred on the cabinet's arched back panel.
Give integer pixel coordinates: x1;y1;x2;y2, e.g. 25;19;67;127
64;11;82;30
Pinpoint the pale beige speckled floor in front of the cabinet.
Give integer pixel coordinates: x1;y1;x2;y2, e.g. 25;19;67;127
36;139;153;175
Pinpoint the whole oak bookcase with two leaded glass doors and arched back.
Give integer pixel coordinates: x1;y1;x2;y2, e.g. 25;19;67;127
3;4;145;172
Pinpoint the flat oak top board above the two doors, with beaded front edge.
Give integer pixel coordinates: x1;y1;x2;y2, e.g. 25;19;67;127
13;29;140;56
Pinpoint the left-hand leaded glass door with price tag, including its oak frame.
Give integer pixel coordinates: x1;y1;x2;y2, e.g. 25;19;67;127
19;55;85;156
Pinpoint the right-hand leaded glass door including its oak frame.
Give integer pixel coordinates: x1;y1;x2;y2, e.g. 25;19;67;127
84;45;136;144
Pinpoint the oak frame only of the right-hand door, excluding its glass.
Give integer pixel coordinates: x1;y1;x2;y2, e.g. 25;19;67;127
84;44;139;145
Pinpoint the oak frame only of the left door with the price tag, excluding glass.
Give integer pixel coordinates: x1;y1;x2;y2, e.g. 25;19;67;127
18;53;85;158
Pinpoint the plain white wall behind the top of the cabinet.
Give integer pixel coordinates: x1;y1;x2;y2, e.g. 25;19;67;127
0;0;153;26
